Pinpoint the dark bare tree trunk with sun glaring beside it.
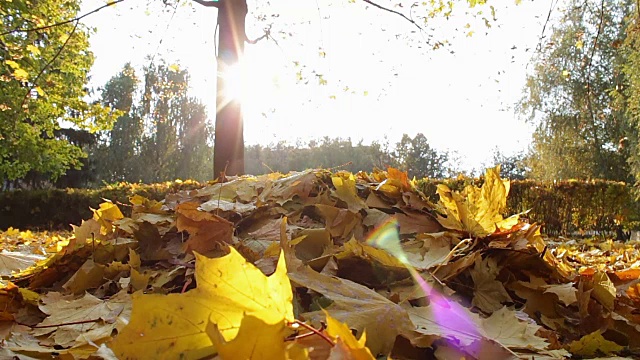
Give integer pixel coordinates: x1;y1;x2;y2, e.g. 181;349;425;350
213;0;247;177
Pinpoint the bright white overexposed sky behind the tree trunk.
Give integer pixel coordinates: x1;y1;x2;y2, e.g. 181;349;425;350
81;0;550;170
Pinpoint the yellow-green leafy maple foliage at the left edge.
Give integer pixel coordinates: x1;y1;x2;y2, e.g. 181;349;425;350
0;0;112;180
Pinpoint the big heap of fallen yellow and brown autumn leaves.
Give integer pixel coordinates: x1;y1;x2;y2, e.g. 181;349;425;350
0;168;640;359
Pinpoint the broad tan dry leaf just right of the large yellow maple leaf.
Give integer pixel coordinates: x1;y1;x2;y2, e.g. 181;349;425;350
289;267;413;354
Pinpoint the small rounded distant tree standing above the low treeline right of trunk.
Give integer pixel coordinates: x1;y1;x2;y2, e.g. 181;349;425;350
394;133;448;178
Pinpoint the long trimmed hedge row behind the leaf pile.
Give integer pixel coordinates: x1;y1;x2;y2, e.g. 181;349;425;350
0;178;640;236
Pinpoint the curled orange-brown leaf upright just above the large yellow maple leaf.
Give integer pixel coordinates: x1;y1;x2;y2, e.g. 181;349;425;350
176;202;233;254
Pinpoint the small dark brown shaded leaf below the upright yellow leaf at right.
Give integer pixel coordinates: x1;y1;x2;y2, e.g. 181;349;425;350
469;257;512;314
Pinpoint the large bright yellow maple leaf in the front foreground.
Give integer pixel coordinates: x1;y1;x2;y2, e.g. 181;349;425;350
111;248;294;359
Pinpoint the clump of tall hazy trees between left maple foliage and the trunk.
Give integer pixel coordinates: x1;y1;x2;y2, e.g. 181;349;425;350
93;62;212;182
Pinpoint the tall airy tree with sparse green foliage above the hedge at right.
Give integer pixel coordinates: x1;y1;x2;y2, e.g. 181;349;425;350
520;0;633;180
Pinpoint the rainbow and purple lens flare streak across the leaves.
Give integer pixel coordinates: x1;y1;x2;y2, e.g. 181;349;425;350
366;218;484;353
